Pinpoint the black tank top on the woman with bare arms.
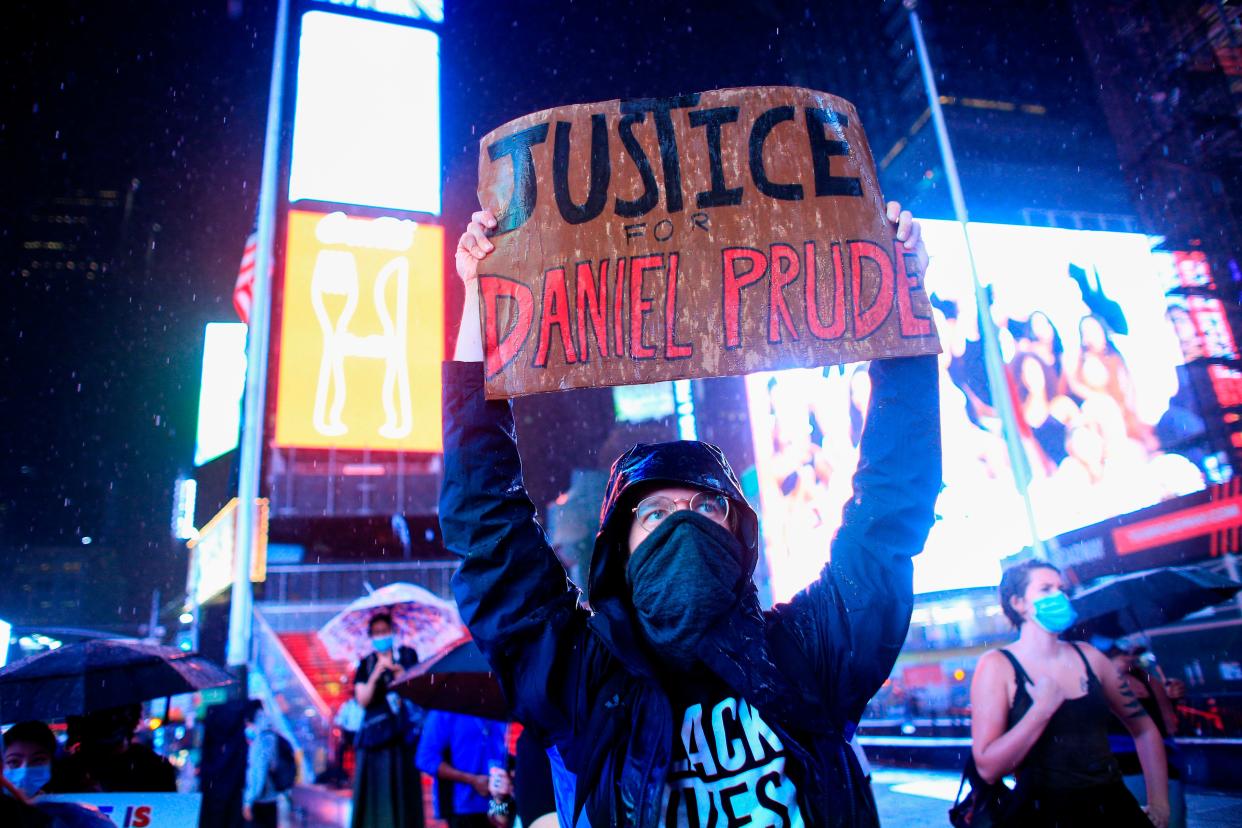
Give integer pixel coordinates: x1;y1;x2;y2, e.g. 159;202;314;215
1001;644;1122;791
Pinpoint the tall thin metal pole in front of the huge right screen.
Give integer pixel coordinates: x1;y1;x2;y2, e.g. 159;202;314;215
905;0;1047;559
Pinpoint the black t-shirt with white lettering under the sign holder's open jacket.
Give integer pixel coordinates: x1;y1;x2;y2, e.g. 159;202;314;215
661;682;806;828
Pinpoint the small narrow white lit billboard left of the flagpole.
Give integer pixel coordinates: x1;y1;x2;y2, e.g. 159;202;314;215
194;322;246;466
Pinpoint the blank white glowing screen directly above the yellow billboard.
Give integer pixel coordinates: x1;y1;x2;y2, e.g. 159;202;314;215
289;11;440;215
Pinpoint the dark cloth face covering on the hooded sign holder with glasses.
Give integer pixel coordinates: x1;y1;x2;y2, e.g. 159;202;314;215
626;510;750;668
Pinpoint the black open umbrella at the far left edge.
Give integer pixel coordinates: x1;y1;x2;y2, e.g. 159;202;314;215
0;639;233;721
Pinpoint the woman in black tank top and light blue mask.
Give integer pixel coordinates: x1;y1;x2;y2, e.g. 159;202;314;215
970;560;1169;828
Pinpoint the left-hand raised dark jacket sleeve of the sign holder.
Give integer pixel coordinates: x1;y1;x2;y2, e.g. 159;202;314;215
440;362;576;720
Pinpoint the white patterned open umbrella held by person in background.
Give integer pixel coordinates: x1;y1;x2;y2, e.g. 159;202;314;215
319;583;466;660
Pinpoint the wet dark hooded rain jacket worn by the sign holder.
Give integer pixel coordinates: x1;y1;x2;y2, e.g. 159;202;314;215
440;356;940;828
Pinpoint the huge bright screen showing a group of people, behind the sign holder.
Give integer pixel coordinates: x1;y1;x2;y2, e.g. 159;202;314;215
746;221;1228;601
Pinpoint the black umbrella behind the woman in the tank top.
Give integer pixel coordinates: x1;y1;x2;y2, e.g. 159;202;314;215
1072;566;1242;638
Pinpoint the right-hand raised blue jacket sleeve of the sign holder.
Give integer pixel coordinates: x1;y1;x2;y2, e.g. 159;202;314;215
776;355;940;721
